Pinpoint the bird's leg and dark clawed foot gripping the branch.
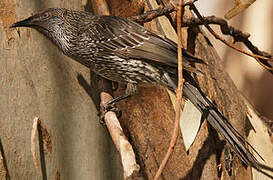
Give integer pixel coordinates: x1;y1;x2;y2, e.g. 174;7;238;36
99;83;137;124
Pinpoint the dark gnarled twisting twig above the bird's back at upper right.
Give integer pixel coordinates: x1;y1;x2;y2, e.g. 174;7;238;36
129;0;273;72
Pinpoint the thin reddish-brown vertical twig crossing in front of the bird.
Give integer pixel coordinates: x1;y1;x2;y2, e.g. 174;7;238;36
154;0;184;180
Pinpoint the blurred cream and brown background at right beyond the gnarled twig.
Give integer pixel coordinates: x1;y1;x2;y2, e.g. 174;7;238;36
196;0;273;125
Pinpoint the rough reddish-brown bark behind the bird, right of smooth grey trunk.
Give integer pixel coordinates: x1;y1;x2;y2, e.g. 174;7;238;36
111;0;251;179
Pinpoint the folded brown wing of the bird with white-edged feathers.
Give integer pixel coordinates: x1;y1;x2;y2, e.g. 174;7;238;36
77;16;201;67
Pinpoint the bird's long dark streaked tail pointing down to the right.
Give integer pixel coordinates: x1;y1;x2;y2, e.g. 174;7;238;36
183;73;273;177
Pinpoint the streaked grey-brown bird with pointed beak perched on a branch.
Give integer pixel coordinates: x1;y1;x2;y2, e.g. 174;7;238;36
11;8;269;174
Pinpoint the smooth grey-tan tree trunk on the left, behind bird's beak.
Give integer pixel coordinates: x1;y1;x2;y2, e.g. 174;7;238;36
0;0;121;180
